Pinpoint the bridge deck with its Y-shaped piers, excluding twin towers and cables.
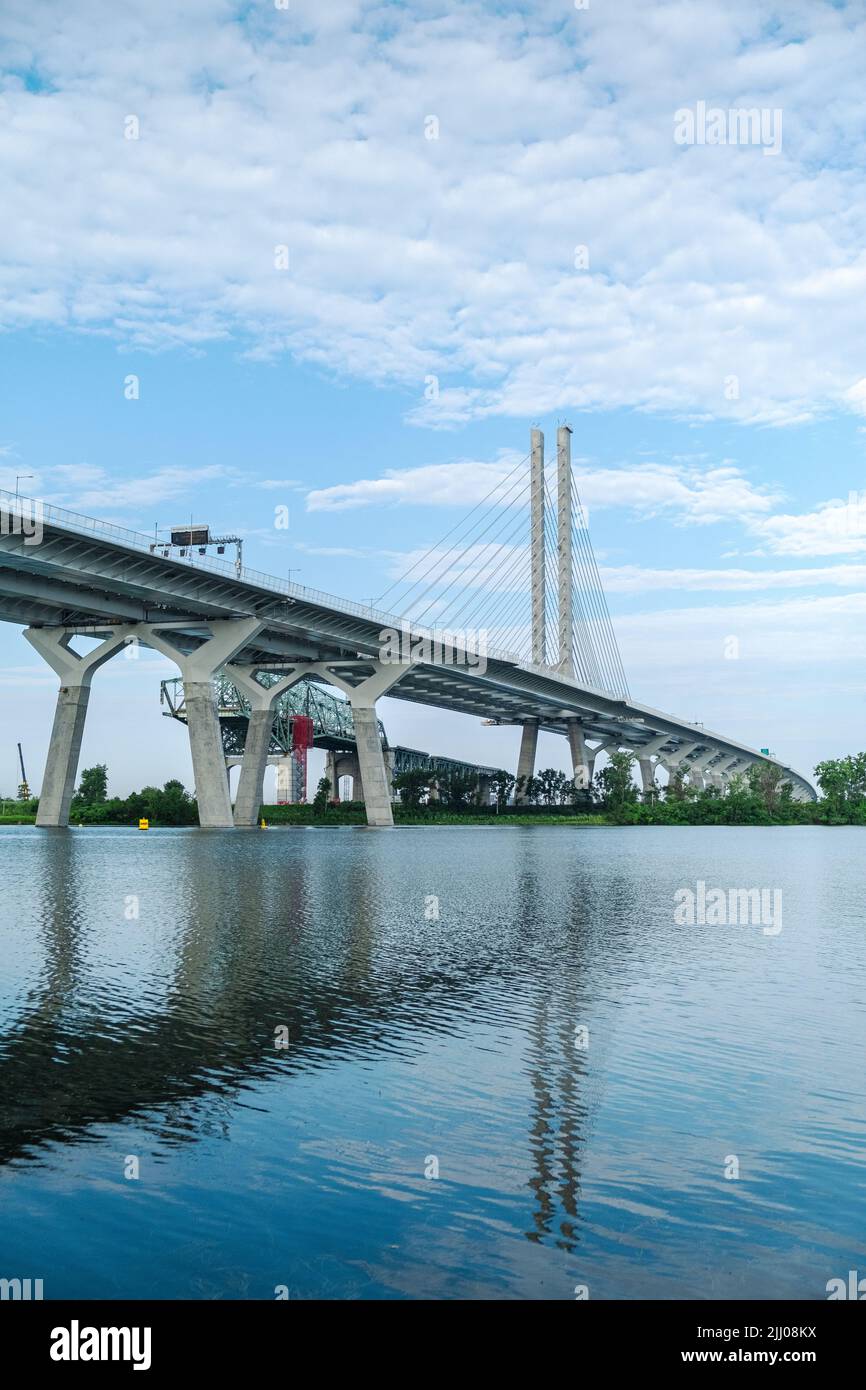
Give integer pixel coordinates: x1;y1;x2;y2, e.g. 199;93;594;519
0;480;815;826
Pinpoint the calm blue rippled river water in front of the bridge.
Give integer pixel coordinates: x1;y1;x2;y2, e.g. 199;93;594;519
0;826;866;1300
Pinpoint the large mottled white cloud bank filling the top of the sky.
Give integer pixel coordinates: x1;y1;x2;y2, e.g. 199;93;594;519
0;0;866;425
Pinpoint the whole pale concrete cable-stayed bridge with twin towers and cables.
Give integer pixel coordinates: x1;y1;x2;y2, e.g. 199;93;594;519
0;427;815;827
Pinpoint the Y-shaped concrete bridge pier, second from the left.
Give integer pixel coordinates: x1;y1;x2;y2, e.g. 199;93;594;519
136;617;263;830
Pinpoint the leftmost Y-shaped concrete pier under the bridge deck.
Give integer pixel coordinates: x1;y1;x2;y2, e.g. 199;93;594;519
24;627;133;826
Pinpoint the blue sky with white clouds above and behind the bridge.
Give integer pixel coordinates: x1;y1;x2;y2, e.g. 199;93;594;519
0;0;866;792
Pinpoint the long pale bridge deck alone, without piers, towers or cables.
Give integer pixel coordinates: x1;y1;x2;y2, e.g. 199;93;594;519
0;492;816;799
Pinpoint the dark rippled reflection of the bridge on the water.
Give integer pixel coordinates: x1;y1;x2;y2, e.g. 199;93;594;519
0;830;608;1293
